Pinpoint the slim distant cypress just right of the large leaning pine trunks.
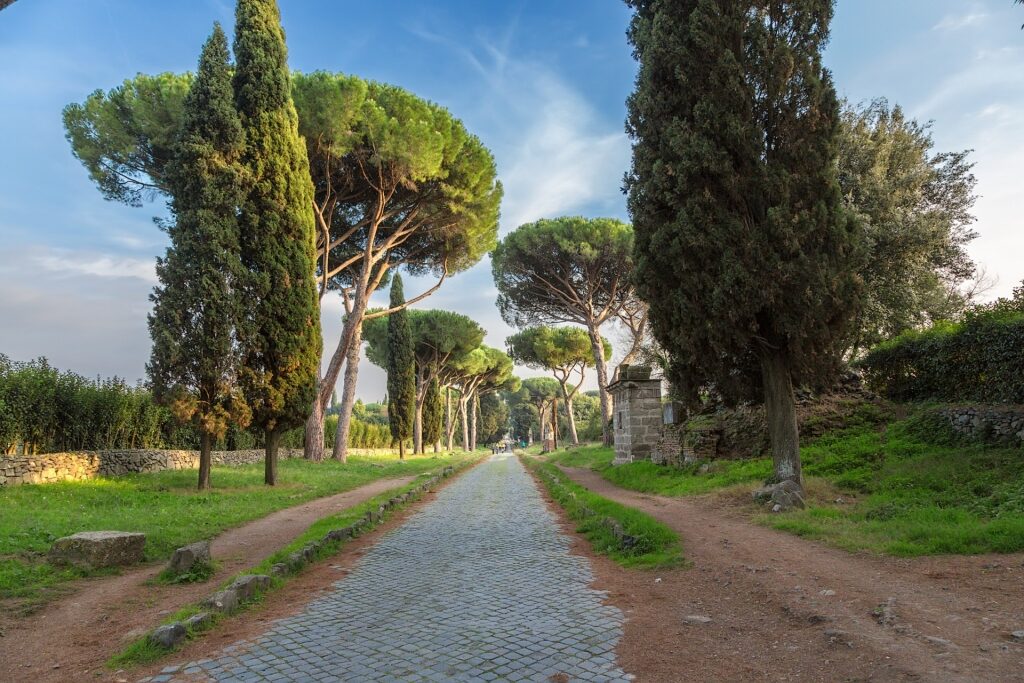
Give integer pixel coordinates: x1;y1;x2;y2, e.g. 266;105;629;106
387;274;416;459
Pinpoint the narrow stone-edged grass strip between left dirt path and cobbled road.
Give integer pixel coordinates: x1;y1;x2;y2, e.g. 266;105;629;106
106;456;478;669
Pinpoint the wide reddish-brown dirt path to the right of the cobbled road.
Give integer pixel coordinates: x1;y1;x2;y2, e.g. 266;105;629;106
563;468;1024;682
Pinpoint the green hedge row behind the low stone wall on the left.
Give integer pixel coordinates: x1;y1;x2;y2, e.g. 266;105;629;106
0;353;391;454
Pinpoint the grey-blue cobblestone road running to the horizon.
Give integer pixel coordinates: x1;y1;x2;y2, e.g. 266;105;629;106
146;455;632;683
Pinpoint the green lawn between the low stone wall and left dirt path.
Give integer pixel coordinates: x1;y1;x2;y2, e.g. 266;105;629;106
0;454;479;607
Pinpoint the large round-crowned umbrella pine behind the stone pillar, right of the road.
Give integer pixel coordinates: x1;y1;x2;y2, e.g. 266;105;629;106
492;217;633;443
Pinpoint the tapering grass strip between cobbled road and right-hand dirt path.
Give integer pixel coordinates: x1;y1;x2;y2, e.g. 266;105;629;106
522;457;682;568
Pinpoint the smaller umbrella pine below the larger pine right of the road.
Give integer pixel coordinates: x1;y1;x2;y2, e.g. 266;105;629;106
505;327;611;445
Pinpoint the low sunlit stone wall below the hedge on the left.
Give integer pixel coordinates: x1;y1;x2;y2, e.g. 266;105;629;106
0;449;393;486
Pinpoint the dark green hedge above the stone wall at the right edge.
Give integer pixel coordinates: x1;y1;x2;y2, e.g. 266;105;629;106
858;310;1024;403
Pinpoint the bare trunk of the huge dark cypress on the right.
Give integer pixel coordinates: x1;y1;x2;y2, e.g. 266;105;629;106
761;350;804;486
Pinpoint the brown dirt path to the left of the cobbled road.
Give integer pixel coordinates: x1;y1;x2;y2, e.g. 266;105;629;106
0;476;415;683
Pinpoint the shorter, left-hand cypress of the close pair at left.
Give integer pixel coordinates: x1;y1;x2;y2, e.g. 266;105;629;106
146;25;249;489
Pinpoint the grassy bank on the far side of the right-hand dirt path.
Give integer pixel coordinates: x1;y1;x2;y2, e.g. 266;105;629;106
553;412;1024;557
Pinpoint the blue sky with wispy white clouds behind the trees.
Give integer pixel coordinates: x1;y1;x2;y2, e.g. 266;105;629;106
0;0;1024;400
